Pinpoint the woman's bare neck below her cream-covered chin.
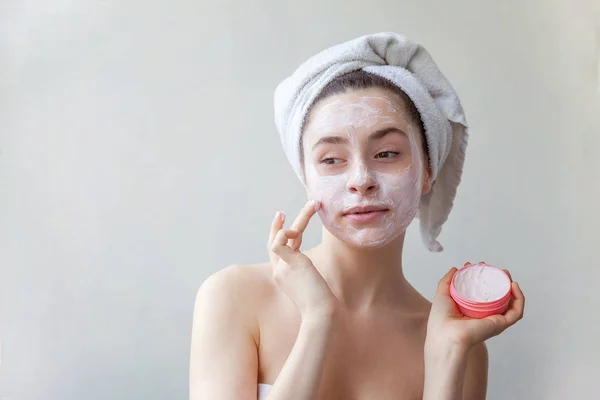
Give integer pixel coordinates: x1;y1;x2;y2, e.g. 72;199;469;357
307;229;418;311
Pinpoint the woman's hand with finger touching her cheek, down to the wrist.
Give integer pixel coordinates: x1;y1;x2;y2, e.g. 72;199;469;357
268;201;338;320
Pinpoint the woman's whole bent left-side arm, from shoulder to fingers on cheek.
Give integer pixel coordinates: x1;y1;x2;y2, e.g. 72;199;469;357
190;202;338;400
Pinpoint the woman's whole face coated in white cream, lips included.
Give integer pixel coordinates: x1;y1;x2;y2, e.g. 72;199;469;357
305;96;423;248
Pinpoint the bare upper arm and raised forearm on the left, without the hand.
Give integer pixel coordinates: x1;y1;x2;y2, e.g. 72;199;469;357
190;267;334;400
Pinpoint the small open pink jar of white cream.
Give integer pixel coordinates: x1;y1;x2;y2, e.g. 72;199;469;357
450;262;512;318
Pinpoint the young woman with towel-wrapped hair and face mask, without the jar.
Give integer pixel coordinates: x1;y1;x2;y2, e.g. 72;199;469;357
190;34;524;400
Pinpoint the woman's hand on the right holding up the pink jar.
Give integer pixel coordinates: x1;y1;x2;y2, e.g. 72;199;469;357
426;263;525;349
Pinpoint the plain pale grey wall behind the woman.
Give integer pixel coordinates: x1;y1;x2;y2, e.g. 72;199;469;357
0;0;600;400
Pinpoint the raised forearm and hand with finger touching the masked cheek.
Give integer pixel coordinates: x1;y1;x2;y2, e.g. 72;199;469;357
267;201;339;400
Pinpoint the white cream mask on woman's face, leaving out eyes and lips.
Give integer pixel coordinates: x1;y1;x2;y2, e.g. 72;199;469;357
305;96;423;247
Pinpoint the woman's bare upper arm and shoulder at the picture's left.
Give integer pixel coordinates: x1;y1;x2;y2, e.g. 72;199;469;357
190;267;258;400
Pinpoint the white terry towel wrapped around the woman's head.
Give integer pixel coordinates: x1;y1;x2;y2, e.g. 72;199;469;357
275;32;468;251
